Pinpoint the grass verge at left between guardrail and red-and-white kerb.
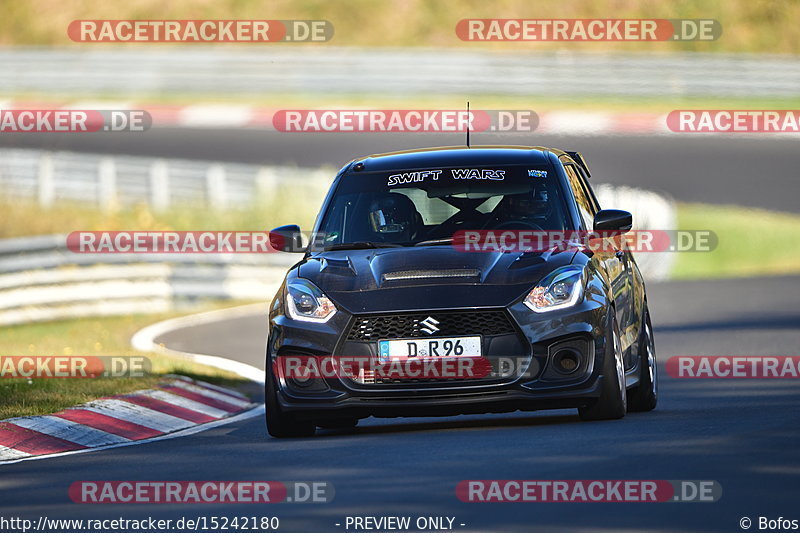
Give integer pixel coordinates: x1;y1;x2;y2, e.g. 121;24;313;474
0;302;256;420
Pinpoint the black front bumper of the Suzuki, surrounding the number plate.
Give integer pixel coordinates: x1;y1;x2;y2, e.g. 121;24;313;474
267;290;607;419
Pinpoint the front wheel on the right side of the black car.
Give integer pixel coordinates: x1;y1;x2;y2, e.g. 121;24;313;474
578;308;628;421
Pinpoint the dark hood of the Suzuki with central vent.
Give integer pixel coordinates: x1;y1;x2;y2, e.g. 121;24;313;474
296;246;576;313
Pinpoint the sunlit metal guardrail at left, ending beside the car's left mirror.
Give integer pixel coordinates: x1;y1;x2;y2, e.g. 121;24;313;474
0;235;298;325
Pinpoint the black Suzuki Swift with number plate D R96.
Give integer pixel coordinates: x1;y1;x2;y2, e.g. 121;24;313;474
265;146;657;437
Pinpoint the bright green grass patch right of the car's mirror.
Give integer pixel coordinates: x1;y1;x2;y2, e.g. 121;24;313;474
672;204;800;279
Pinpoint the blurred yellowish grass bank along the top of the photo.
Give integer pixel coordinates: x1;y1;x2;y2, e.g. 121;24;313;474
0;0;800;54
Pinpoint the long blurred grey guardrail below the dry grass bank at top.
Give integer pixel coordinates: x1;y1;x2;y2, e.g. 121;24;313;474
0;46;800;97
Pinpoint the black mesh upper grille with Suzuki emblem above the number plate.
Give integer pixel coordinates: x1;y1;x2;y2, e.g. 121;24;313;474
347;310;516;342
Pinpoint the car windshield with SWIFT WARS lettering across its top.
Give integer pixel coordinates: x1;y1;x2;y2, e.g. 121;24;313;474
318;166;572;249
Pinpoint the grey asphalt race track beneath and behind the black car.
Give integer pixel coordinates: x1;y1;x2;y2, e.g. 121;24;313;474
0;130;800;532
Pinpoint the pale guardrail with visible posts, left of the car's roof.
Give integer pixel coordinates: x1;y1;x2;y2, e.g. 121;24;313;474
0;149;336;210
